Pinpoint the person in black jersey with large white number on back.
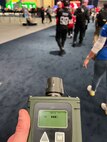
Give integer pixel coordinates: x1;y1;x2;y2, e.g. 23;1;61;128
55;0;72;55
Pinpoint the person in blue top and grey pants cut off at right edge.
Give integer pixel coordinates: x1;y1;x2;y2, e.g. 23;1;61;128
83;22;107;114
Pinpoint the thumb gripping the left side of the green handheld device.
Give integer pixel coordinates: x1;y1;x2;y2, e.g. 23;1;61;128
7;109;30;142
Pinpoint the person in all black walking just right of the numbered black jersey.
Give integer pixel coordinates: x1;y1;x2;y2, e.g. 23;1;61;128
72;0;89;47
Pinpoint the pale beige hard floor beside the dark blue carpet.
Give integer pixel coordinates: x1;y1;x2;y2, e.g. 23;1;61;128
0;16;55;44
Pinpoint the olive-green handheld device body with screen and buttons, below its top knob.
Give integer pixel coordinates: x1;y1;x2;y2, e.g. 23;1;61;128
28;96;82;142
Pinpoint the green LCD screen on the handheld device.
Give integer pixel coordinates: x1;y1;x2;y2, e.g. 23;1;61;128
38;110;68;128
